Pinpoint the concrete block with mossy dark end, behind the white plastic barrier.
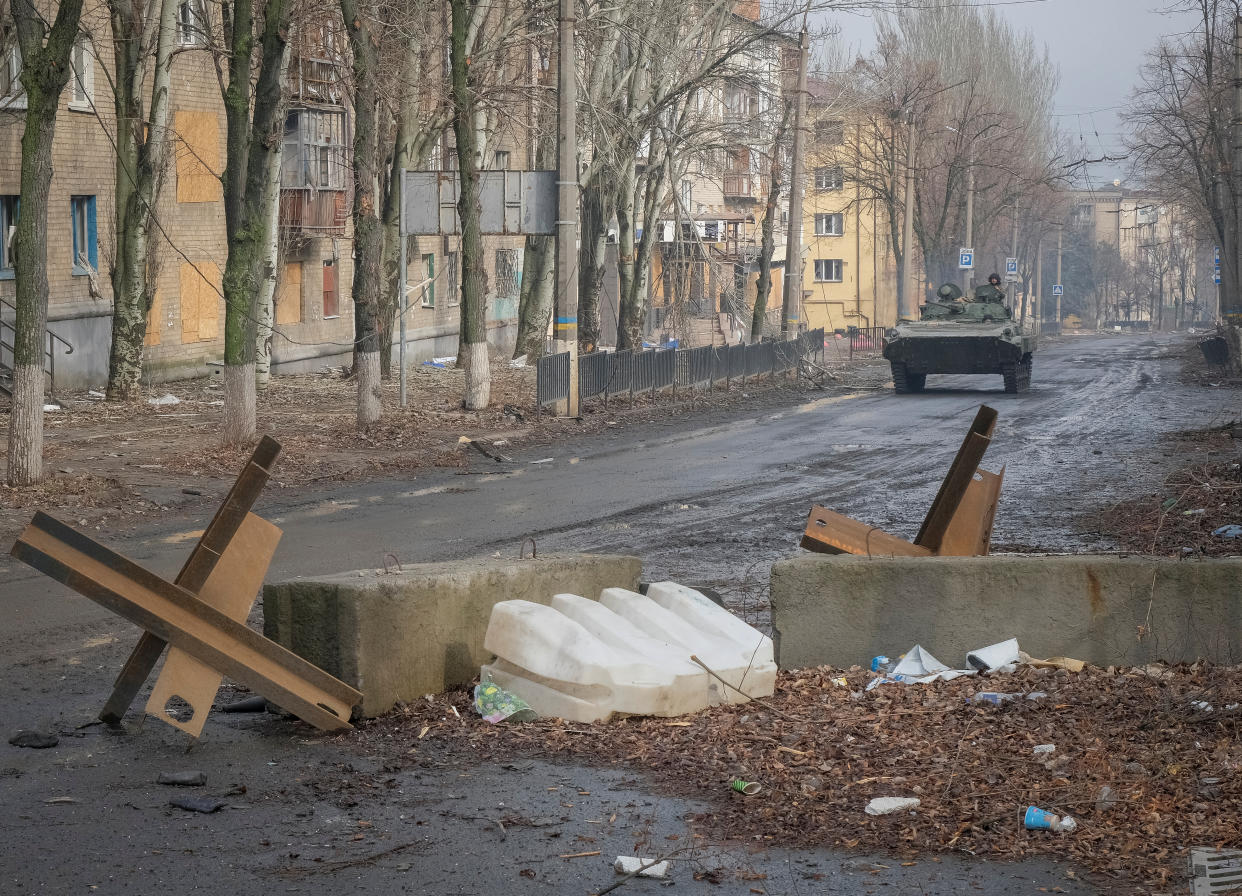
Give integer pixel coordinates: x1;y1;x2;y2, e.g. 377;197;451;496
263;554;642;718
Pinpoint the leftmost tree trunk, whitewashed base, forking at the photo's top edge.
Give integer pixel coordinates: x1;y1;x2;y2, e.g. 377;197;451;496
7;0;82;486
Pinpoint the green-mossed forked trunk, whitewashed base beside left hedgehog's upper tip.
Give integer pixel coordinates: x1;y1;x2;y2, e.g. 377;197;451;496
221;0;289;445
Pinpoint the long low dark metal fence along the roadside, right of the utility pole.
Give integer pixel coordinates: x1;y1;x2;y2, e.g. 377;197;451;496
535;327;823;406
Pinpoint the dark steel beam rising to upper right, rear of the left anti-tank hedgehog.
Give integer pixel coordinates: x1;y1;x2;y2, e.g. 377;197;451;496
99;436;281;725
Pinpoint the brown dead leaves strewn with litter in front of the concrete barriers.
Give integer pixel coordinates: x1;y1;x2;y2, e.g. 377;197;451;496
361;664;1242;892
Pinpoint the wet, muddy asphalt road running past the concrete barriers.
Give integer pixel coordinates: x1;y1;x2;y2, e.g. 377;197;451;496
0;337;1235;896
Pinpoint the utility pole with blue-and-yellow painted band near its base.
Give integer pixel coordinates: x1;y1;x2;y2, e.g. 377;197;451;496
554;0;579;416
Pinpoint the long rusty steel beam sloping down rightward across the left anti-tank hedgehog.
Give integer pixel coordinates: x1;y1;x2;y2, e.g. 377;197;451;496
12;513;361;731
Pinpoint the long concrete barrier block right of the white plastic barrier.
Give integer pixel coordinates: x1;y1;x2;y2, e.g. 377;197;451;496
771;554;1242;669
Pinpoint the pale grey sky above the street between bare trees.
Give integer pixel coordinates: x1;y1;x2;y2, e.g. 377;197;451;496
830;0;1192;186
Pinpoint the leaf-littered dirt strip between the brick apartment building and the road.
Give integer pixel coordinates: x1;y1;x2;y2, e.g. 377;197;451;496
0;352;889;542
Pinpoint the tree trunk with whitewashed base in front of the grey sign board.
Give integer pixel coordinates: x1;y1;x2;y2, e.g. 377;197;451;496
450;0;492;410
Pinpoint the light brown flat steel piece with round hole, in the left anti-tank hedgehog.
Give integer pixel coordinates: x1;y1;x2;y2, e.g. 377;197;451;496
147;513;281;737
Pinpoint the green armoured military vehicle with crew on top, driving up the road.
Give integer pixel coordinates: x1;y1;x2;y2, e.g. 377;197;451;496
884;283;1036;393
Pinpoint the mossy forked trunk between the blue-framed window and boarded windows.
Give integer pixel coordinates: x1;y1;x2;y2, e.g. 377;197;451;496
108;0;178;401
